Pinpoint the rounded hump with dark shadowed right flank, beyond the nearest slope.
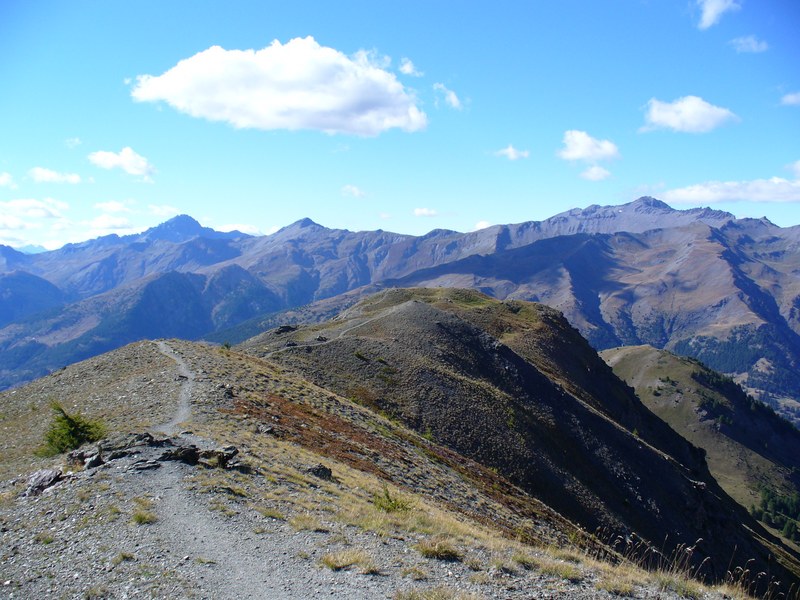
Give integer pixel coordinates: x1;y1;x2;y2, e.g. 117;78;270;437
242;289;797;578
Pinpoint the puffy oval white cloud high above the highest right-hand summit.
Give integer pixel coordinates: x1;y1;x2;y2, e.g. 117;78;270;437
639;96;739;133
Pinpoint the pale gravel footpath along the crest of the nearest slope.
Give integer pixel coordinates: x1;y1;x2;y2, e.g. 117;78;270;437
145;341;388;600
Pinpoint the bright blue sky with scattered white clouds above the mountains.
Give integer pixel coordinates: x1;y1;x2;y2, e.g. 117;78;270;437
0;0;800;249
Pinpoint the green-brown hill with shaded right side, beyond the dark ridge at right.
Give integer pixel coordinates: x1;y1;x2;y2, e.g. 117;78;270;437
601;346;800;540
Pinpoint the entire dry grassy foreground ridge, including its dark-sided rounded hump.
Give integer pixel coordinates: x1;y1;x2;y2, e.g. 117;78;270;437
0;289;800;598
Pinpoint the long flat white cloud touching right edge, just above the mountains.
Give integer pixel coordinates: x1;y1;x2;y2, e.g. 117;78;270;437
661;177;800;204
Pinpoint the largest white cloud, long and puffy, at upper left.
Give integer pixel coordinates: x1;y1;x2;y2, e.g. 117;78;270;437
131;36;427;136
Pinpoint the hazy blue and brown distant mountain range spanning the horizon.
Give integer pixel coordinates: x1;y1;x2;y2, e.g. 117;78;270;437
0;197;800;420
